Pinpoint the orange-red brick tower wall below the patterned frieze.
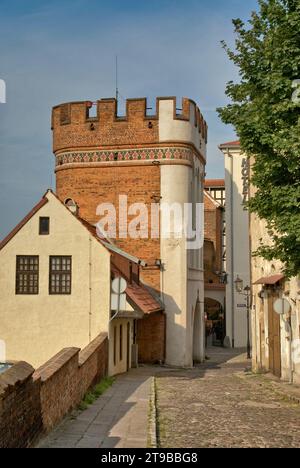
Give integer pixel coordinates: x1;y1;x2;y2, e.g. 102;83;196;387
56;165;160;290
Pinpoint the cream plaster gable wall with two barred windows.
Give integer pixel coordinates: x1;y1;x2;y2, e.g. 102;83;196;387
0;193;110;367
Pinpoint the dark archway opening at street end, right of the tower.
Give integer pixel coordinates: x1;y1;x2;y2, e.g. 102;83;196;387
204;297;225;346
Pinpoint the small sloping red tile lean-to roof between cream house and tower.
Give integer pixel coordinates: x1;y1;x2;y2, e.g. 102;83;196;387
111;264;163;314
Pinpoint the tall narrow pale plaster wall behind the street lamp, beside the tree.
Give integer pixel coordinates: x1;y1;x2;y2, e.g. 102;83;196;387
224;150;250;348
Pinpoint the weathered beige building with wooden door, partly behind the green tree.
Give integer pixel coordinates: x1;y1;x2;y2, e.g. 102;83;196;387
250;181;300;384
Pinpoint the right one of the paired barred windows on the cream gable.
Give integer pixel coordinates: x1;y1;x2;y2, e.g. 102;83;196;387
49;256;72;294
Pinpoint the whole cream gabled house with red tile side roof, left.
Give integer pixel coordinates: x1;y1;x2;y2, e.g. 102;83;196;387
0;191;162;375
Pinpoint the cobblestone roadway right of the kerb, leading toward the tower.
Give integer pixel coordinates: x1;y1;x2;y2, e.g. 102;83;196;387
156;350;300;448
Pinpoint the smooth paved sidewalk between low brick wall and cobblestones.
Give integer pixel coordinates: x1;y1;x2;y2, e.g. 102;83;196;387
39;368;153;448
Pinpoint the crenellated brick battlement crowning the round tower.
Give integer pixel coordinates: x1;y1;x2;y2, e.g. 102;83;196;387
51;97;207;153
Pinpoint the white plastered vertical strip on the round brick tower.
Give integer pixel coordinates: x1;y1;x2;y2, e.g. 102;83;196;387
159;100;206;367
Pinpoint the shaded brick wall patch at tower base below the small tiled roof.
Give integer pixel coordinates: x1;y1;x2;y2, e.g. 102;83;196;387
137;312;166;364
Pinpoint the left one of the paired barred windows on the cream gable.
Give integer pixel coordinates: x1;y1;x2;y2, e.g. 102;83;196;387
16;255;39;294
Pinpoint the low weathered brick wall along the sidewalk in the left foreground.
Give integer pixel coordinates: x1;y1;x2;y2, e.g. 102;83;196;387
0;333;108;448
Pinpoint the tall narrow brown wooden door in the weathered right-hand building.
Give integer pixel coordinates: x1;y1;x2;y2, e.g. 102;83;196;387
268;293;281;377
